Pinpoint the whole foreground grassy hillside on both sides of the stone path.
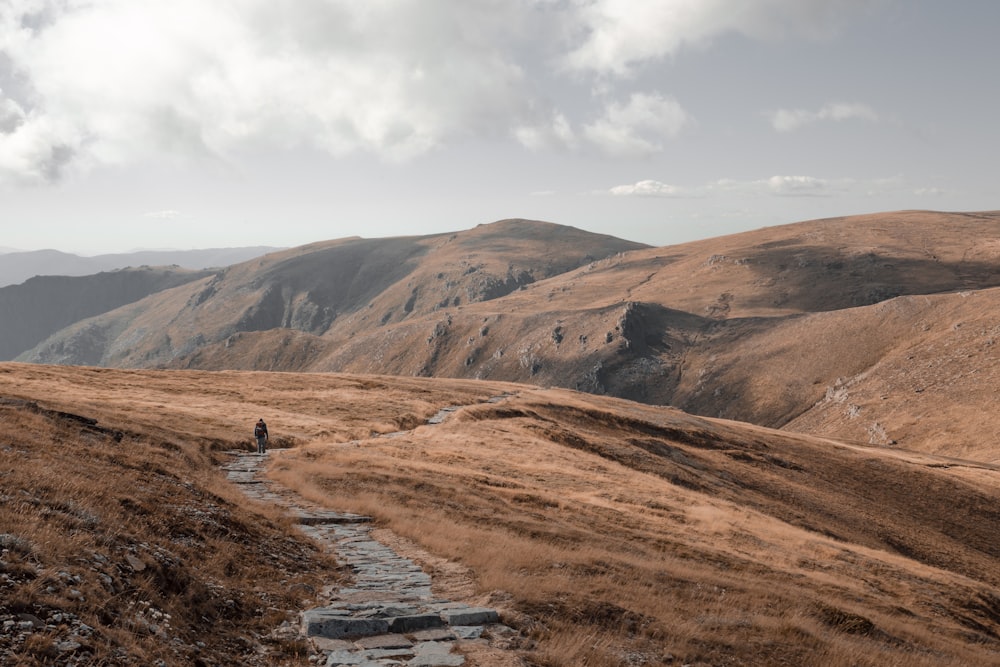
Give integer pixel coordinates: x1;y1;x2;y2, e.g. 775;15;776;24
0;364;1000;667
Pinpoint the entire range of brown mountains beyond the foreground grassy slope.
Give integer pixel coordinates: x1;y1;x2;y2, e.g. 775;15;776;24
0;211;1000;462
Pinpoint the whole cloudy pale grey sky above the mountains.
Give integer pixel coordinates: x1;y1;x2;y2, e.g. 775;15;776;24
0;0;1000;255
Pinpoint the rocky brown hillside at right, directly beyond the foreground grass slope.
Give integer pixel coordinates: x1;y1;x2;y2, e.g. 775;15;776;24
174;212;1000;461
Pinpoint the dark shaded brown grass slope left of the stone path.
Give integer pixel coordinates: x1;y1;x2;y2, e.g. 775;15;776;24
0;368;350;665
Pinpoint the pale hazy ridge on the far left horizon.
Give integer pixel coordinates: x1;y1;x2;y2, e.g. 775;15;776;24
0;246;276;287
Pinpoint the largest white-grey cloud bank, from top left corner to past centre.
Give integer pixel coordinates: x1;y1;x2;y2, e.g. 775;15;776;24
0;0;870;183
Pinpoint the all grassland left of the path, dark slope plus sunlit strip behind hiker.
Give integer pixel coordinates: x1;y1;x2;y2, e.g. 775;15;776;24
0;365;516;666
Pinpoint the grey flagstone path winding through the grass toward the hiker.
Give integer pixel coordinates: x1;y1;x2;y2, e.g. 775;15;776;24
224;400;514;667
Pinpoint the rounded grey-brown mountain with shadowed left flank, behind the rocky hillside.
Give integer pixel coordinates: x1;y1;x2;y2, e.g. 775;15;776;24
21;220;643;370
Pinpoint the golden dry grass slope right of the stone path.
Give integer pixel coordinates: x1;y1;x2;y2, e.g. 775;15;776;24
272;391;1000;666
